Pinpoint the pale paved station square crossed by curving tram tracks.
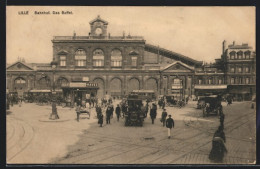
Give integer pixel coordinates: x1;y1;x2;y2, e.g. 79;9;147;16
7;102;256;164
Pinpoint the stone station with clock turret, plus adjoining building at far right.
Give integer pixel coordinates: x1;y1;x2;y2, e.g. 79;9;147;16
6;16;256;102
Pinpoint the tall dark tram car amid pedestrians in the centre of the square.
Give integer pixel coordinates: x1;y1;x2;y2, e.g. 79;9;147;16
125;94;145;126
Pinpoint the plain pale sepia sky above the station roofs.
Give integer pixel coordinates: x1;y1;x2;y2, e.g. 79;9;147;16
6;6;255;64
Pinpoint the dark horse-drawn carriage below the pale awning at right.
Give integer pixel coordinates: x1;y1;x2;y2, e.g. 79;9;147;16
198;95;221;117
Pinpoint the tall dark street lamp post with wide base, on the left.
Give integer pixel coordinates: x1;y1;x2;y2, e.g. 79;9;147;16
50;61;59;120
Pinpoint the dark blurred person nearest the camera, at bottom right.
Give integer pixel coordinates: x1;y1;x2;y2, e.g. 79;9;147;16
209;131;227;163
